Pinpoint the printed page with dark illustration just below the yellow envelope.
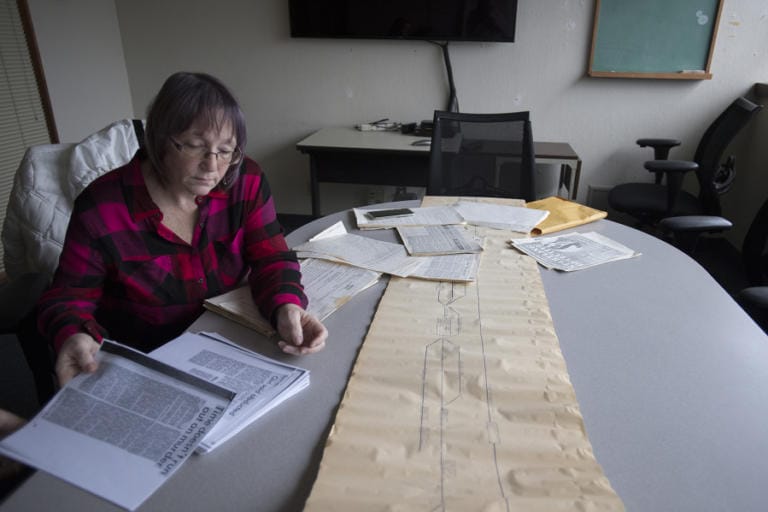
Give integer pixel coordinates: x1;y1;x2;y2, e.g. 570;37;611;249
509;232;640;272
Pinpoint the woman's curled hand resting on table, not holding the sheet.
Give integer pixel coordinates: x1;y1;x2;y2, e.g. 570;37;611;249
277;304;328;355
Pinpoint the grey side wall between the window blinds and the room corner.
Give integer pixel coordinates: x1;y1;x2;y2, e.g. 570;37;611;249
27;0;133;142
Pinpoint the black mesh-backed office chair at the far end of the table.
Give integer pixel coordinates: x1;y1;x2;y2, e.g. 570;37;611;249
427;111;536;201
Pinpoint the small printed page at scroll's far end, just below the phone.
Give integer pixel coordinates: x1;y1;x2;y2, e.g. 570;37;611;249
397;226;483;256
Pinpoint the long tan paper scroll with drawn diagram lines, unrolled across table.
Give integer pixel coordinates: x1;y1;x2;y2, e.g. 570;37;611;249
305;195;624;512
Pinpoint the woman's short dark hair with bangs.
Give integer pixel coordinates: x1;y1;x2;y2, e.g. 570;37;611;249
145;72;246;188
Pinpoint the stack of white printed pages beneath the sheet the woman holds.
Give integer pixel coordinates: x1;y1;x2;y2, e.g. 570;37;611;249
150;332;309;453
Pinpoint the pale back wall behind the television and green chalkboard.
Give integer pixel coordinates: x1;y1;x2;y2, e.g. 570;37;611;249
30;0;768;248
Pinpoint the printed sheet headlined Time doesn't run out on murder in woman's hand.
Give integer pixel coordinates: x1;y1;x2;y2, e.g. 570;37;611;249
0;340;235;510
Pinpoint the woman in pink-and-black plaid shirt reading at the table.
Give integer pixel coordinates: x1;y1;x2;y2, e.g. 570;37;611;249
38;73;327;385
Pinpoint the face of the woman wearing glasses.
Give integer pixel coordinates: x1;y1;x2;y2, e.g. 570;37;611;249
163;116;237;196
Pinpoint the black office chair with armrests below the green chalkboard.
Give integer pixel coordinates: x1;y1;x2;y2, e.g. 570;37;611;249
608;98;762;232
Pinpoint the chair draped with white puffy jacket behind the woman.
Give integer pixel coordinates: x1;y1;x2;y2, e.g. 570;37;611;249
0;119;144;405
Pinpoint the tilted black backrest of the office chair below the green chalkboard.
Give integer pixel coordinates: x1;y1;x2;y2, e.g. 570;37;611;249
693;98;763;215
